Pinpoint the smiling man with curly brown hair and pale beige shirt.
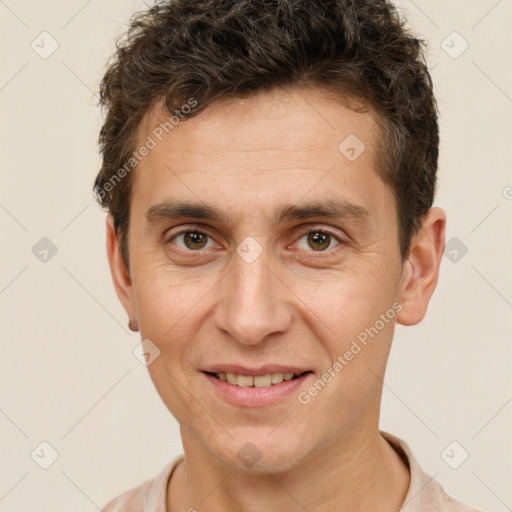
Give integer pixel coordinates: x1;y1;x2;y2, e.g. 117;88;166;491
95;0;484;512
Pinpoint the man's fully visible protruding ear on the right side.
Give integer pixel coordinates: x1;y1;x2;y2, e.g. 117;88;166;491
396;208;446;325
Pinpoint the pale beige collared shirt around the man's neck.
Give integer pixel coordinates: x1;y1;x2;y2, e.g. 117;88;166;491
102;431;480;512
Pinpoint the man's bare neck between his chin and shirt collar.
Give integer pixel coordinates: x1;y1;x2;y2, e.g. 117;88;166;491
167;429;410;512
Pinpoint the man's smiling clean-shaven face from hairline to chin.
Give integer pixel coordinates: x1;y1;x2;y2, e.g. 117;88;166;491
109;86;440;471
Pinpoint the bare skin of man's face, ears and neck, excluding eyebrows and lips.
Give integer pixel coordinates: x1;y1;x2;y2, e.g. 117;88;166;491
107;89;445;512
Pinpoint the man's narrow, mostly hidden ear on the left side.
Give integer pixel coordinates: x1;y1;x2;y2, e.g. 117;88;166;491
106;213;139;332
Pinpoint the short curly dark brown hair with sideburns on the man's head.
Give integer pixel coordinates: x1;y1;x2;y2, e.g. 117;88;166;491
94;0;439;263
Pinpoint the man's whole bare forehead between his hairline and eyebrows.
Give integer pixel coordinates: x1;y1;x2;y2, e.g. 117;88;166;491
132;85;391;221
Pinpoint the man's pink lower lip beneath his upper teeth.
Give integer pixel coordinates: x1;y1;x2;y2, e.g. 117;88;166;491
203;372;313;407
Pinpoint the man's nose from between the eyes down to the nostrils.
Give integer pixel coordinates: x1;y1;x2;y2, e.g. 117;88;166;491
215;248;291;345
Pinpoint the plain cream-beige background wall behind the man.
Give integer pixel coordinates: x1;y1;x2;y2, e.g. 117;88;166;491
0;0;512;512
